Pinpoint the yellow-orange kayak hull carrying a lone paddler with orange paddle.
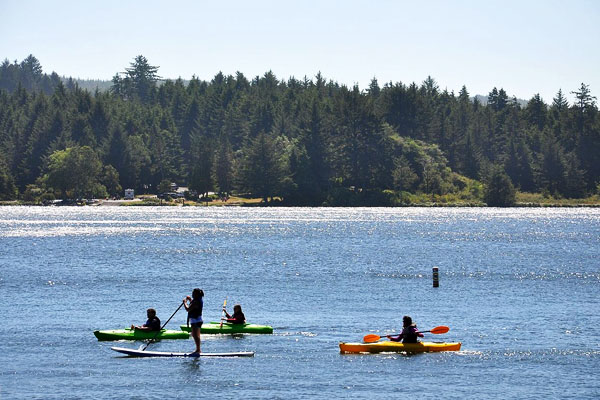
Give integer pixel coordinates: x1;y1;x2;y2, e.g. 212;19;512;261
340;341;461;353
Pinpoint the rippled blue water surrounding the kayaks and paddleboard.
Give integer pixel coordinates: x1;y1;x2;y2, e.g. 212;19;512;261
0;207;600;400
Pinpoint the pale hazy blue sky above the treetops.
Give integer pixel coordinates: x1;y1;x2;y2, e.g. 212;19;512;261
0;0;600;103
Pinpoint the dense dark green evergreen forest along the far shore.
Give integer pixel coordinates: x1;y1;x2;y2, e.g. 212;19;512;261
0;55;600;206
